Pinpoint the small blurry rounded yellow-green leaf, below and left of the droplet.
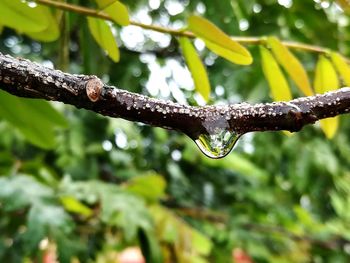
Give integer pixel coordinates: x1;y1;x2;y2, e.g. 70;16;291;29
127;174;166;202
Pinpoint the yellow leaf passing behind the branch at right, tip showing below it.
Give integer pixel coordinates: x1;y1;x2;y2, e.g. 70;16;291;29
314;55;339;139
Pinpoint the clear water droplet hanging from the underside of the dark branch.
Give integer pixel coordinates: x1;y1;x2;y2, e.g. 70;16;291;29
195;130;241;159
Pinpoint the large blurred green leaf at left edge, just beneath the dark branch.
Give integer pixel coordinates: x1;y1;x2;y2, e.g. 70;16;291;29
0;91;67;149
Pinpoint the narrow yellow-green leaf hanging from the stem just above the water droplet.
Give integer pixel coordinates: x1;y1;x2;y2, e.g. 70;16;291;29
179;37;210;101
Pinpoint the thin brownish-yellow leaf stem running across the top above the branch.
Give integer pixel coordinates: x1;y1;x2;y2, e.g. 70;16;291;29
35;0;328;53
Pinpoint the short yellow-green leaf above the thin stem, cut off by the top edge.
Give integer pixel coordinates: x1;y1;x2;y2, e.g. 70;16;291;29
96;0;130;26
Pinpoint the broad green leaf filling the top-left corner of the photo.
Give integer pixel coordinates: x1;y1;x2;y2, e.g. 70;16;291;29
0;0;51;33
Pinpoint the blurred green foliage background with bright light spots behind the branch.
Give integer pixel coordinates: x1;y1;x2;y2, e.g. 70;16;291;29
0;0;350;263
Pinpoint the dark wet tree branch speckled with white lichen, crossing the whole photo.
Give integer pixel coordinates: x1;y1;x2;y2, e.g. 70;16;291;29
0;53;350;139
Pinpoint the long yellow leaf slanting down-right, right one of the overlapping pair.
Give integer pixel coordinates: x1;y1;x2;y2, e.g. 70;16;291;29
267;37;313;96
